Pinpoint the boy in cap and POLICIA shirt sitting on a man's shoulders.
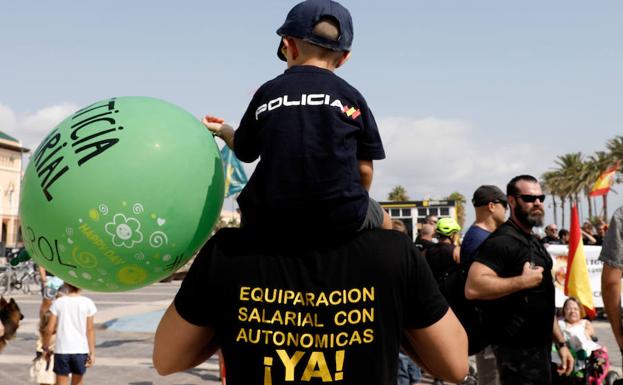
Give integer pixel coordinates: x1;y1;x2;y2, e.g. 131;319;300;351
203;0;391;233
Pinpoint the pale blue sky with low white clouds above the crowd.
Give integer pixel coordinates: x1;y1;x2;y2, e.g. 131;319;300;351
0;0;623;226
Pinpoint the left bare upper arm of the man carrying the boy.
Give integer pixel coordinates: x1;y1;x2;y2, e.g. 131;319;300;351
153;304;218;376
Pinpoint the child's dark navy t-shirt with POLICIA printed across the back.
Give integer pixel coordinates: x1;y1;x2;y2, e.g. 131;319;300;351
234;66;385;232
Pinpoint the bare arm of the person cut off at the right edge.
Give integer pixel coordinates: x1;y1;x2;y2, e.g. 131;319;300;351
601;263;623;349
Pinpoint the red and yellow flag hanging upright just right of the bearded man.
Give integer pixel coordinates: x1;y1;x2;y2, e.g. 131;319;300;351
565;203;597;318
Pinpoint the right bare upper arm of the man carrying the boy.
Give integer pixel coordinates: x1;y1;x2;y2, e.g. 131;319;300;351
403;308;469;383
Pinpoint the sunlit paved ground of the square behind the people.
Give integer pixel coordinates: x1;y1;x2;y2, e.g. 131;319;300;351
0;281;621;385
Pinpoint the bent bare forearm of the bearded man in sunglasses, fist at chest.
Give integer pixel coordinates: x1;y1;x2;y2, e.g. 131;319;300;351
465;261;543;300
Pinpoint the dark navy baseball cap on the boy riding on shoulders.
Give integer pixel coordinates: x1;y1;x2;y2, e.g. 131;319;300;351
277;0;353;61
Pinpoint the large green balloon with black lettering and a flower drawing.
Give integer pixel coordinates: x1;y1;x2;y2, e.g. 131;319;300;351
20;97;224;291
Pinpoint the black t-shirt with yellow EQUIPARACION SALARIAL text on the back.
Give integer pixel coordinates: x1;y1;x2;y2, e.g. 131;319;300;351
175;229;448;385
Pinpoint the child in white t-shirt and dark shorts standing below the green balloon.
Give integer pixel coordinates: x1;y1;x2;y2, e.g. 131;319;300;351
43;282;97;385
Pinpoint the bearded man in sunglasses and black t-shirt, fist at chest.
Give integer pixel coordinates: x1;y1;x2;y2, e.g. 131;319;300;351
465;175;573;385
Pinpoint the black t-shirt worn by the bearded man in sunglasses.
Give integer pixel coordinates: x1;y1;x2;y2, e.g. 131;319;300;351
475;220;555;347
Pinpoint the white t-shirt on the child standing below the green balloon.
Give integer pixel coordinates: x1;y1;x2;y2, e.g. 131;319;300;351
50;295;97;354
